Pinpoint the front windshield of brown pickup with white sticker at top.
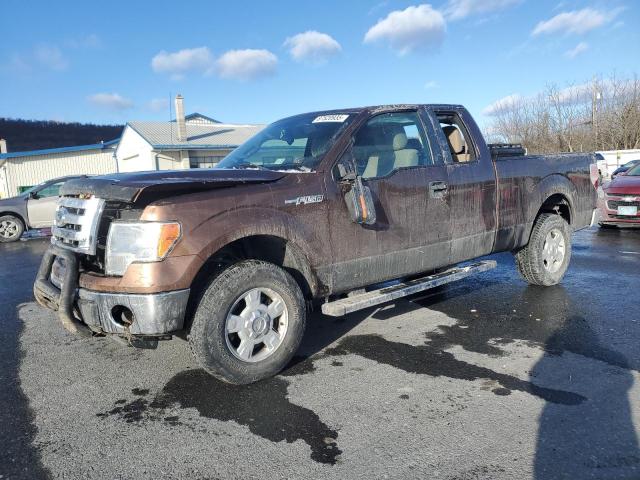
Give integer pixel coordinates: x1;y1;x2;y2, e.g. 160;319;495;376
216;113;355;172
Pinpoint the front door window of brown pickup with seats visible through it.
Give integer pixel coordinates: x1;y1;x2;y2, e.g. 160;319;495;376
353;112;434;179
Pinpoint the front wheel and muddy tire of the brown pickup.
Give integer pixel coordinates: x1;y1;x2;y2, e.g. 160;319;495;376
189;260;306;385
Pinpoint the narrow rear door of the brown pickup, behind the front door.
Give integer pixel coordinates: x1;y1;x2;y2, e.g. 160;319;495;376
431;109;496;264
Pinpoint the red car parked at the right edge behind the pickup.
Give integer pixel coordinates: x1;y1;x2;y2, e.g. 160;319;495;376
598;165;640;226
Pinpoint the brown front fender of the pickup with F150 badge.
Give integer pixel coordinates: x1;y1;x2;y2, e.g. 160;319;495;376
142;173;331;292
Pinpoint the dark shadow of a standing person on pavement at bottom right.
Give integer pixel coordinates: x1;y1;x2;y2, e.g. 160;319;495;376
531;287;640;480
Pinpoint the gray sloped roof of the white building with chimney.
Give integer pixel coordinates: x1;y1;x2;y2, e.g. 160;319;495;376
128;121;264;150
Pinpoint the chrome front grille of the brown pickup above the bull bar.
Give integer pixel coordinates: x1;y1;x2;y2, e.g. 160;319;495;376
51;196;105;255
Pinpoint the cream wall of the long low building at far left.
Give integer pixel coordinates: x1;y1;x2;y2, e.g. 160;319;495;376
5;148;116;197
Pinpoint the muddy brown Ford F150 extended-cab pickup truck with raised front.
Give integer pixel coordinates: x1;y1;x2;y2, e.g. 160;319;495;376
34;105;598;384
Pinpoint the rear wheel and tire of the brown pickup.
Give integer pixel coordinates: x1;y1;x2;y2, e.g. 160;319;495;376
515;213;571;287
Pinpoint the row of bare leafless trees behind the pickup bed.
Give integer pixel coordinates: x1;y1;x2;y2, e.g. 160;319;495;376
484;76;640;153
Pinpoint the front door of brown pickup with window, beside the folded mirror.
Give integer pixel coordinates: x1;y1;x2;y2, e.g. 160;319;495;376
327;110;451;291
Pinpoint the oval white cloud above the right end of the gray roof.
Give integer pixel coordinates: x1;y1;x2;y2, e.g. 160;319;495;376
215;49;278;81
